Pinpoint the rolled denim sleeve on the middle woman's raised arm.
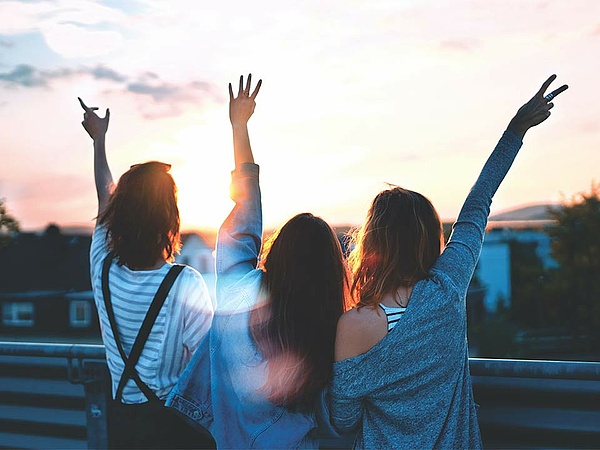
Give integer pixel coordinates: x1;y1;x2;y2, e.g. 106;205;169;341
216;163;262;308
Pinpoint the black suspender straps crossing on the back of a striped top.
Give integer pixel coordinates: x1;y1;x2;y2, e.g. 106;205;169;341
102;253;184;401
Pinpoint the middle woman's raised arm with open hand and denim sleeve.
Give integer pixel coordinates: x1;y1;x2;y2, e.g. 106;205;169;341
217;75;262;288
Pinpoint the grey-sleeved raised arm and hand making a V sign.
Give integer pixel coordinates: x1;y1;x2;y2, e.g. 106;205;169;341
435;75;568;291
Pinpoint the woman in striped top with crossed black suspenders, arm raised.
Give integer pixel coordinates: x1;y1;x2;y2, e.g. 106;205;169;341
79;99;214;448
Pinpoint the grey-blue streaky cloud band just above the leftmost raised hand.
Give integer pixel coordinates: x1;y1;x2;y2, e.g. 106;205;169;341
0;64;221;119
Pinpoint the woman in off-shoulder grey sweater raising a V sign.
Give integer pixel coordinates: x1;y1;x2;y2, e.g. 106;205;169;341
330;75;567;449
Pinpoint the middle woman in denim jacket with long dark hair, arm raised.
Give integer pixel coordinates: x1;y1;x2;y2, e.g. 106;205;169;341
168;75;347;449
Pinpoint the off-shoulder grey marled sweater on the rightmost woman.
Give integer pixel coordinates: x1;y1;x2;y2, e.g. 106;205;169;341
330;131;521;449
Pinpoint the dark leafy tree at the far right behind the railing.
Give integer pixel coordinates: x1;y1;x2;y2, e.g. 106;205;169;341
549;183;600;353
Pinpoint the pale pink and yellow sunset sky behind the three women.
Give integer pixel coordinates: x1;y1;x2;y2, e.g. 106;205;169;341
0;0;600;230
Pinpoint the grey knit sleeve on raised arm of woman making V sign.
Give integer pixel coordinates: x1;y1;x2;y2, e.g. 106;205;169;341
434;131;522;292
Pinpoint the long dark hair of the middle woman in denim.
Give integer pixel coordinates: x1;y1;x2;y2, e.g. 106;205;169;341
251;213;348;409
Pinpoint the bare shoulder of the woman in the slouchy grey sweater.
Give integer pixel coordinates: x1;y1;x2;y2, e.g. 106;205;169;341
335;307;387;361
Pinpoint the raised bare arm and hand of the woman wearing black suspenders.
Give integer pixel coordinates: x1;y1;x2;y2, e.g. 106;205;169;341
77;97;114;215
